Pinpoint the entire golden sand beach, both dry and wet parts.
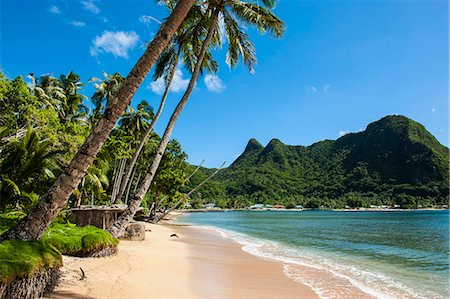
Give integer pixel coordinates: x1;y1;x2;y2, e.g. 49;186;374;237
50;224;318;299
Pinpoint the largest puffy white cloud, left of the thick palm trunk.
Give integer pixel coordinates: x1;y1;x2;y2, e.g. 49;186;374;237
91;31;139;58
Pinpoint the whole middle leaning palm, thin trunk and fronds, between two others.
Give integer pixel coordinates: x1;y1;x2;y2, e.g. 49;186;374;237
115;1;218;202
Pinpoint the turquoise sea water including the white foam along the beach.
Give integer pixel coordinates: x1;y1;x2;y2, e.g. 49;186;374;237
177;211;450;298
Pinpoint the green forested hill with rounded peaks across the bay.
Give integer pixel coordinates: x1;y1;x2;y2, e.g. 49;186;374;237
185;115;449;208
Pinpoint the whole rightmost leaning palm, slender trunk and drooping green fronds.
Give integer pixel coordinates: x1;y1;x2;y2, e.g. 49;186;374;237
108;0;285;237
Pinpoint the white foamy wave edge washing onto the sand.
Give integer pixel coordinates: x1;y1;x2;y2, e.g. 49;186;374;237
193;225;443;299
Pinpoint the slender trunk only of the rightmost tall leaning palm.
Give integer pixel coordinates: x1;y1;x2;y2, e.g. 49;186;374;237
107;11;218;238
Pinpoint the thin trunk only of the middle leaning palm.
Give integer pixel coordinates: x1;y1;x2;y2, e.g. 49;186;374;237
114;49;180;203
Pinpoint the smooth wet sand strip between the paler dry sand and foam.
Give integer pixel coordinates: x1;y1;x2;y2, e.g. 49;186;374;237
173;225;319;299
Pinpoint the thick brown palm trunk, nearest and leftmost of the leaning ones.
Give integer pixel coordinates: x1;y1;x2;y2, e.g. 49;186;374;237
0;0;195;240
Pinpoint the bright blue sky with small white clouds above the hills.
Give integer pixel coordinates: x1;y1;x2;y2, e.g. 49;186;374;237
0;0;449;167
